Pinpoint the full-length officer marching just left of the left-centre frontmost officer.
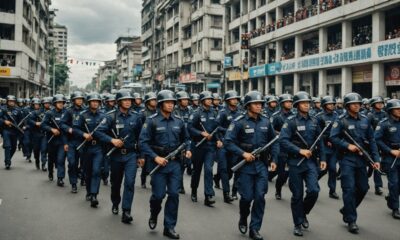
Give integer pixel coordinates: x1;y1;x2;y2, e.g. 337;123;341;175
103;90;144;224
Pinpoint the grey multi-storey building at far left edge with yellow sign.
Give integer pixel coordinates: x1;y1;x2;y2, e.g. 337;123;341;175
0;0;51;98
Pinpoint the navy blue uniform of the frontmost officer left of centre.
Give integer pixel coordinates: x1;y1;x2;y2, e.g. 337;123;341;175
139;113;190;229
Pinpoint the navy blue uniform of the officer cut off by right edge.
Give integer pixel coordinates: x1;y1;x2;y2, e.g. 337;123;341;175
375;116;400;210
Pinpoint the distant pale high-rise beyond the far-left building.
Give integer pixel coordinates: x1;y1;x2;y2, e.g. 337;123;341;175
49;24;68;63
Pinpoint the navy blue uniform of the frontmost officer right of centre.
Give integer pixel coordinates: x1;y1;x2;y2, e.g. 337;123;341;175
224;114;279;231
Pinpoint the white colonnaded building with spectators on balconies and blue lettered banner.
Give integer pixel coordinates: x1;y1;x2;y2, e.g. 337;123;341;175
224;0;400;97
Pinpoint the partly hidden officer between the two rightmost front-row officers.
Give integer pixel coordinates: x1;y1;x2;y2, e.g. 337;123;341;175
367;96;387;195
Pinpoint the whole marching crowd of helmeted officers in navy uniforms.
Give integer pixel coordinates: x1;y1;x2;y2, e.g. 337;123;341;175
0;90;400;240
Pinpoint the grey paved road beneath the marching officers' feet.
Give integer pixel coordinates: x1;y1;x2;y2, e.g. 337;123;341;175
0;151;400;240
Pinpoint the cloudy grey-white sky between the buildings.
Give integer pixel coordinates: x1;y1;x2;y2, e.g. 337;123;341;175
50;0;142;87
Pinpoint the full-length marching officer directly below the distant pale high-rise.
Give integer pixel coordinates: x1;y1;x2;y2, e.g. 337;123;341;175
40;94;67;184
